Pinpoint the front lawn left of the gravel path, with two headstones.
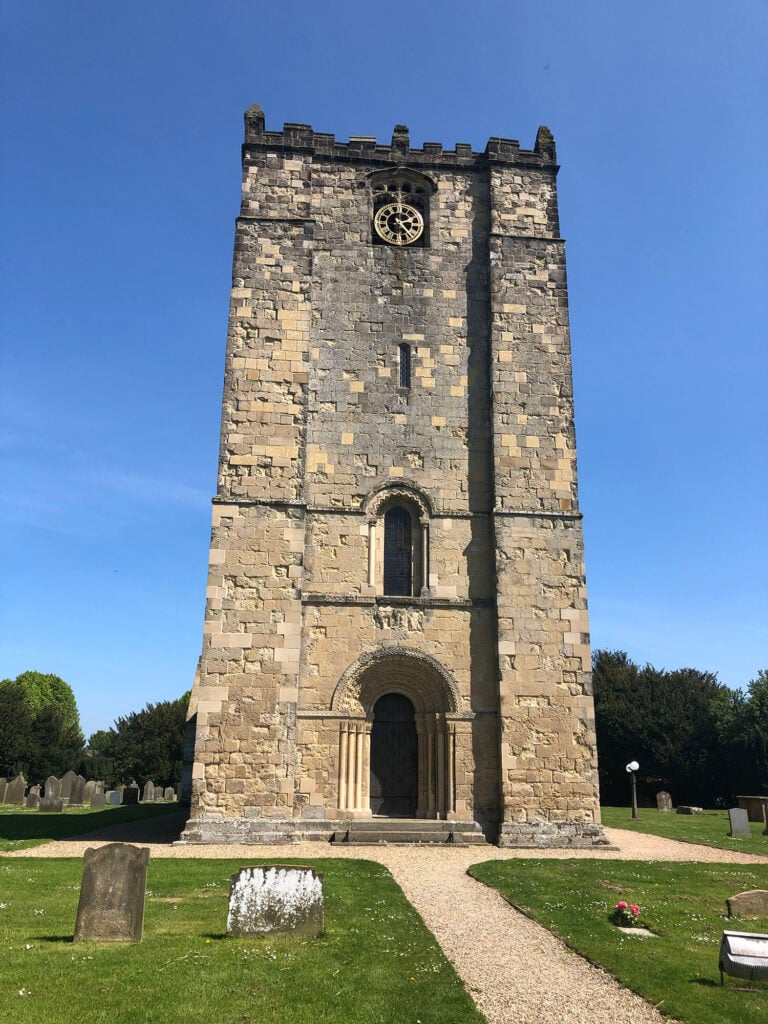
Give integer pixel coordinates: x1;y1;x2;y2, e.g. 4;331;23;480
0;857;483;1024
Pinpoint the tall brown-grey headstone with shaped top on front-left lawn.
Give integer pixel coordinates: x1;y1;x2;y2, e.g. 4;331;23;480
75;843;150;942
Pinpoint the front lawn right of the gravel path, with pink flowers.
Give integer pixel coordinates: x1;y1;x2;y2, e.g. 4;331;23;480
470;860;768;1024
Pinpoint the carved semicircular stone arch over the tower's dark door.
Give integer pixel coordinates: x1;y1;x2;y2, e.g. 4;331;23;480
331;646;462;718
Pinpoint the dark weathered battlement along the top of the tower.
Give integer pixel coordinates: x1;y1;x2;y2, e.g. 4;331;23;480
243;103;557;171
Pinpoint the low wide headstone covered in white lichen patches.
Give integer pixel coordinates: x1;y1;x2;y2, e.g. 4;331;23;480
226;864;323;938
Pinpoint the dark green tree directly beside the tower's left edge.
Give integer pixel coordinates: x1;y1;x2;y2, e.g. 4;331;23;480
96;694;188;786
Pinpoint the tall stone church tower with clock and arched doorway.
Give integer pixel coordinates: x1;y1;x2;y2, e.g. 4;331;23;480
184;106;605;846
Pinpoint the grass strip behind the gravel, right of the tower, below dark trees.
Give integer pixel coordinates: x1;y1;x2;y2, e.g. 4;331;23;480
600;807;768;857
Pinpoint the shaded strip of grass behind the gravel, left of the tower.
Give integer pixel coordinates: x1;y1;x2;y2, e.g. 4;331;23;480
0;803;179;850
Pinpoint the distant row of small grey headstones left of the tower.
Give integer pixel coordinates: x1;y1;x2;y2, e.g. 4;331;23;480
0;771;176;812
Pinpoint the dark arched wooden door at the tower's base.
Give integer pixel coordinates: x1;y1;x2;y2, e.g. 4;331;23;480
371;693;419;818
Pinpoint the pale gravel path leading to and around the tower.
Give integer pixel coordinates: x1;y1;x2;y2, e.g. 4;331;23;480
3;816;768;1024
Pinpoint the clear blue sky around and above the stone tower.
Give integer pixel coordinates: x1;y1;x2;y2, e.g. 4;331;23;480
0;0;768;735
